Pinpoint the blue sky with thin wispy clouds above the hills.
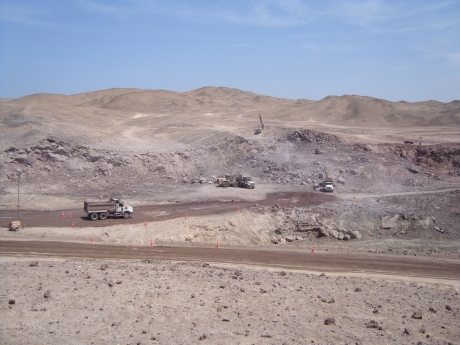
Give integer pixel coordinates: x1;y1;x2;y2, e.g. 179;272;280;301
0;0;460;102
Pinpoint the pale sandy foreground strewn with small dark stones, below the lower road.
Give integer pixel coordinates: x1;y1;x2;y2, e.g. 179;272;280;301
0;258;460;344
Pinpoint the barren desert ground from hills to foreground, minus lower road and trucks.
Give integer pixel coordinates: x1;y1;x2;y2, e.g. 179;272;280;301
0;87;460;344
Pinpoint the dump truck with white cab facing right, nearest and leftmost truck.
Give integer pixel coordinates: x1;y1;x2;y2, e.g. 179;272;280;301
83;198;134;220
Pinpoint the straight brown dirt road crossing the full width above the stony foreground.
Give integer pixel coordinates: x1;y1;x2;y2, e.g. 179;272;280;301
0;241;460;280
